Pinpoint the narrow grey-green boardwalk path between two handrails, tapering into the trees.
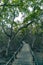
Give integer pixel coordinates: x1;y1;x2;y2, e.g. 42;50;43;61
12;43;34;65
